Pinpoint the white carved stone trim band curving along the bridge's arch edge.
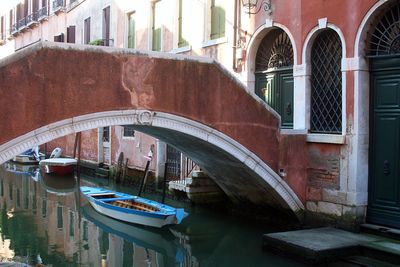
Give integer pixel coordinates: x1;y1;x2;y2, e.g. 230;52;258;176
0;110;304;216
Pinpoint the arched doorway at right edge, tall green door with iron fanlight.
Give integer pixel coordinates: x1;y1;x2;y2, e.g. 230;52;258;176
367;1;400;228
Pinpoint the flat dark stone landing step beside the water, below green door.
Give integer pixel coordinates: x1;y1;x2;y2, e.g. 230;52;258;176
263;228;400;266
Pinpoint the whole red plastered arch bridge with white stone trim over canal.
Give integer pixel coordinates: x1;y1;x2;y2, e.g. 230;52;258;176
0;42;304;218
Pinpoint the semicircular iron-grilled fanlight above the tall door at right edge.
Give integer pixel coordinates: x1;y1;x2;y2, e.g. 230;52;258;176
367;3;400;56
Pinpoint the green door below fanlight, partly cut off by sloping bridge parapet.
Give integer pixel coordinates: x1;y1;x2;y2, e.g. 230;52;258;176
255;69;293;128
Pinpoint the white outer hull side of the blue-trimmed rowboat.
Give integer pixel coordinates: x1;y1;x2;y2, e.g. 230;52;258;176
89;200;176;228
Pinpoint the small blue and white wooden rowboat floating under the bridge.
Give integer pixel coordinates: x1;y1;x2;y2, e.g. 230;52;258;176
81;186;187;228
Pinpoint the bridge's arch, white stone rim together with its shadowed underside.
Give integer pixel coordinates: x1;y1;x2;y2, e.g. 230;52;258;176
0;110;304;215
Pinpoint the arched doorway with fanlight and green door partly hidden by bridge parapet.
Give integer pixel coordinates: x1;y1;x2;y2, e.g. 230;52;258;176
255;29;293;128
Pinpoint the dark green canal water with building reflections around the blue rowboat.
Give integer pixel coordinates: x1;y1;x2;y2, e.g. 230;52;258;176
0;163;362;267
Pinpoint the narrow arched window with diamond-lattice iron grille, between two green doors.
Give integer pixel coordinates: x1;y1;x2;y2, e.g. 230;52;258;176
310;29;342;134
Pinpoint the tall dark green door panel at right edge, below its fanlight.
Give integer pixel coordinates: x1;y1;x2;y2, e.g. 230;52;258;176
367;58;400;228
